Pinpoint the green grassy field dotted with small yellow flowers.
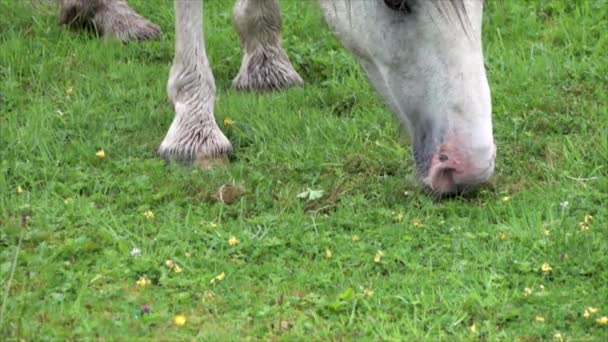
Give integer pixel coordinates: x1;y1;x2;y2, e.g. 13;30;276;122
0;0;608;341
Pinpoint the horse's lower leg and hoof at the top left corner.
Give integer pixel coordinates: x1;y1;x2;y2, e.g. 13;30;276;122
59;0;161;42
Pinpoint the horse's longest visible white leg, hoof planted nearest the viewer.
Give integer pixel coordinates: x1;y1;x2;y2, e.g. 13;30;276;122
158;0;232;167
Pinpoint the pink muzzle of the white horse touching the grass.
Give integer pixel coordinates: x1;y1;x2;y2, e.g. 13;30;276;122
423;145;495;195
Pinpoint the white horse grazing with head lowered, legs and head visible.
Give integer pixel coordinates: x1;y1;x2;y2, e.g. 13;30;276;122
60;0;496;194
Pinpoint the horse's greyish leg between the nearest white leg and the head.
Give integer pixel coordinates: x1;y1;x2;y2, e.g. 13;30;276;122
232;0;304;90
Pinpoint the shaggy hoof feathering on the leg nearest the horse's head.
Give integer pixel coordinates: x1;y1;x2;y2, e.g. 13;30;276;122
232;46;304;90
